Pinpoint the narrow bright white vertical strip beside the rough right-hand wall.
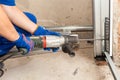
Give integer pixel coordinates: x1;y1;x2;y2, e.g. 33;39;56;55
110;0;113;56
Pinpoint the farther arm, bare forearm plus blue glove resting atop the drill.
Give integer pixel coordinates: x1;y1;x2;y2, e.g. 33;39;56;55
2;5;60;36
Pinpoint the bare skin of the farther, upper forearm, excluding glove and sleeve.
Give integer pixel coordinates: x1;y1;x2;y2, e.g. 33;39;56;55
2;5;37;34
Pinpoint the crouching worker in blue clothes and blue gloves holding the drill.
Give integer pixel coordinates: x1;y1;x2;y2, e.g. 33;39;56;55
0;0;61;56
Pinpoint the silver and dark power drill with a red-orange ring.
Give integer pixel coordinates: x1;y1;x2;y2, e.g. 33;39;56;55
20;34;78;57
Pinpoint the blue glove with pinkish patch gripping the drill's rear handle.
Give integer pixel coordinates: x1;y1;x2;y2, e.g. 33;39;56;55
14;34;34;53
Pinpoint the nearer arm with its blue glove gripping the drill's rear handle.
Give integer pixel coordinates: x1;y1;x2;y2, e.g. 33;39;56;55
0;6;34;52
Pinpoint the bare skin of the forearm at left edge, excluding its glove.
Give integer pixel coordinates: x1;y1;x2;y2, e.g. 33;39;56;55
0;6;19;41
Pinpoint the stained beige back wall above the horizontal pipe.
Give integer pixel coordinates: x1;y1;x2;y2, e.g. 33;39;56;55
16;0;92;26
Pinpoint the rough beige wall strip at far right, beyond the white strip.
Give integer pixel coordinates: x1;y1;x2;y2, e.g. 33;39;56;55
113;0;120;66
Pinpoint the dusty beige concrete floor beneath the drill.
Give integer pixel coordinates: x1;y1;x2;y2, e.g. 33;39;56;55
0;48;114;80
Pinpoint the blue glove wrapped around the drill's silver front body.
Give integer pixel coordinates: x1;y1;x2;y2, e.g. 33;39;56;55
33;26;61;52
